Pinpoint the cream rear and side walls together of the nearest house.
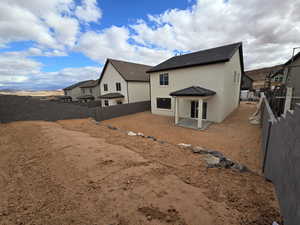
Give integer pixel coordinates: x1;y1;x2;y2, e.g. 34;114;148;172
150;51;241;122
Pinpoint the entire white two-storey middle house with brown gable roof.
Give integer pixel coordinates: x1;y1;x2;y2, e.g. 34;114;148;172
98;59;151;106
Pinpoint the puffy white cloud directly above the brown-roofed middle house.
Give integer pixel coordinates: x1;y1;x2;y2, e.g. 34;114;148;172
76;26;172;65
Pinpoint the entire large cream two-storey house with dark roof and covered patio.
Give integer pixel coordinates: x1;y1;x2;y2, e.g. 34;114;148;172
148;43;244;128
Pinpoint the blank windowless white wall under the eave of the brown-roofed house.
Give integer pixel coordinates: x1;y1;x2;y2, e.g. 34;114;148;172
128;82;150;103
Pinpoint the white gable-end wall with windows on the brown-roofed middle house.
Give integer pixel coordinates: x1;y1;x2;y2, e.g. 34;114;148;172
100;63;128;106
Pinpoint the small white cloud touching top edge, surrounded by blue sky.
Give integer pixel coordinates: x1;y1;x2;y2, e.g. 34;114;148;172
75;0;102;22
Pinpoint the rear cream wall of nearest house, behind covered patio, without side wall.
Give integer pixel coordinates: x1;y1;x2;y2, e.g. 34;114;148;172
150;63;225;122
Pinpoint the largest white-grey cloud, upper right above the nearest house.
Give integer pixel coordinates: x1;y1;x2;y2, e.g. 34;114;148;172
131;0;300;67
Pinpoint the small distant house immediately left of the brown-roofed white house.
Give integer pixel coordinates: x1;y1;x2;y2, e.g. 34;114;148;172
78;80;100;102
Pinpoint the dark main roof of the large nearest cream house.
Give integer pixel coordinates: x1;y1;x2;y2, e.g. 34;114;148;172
147;42;244;72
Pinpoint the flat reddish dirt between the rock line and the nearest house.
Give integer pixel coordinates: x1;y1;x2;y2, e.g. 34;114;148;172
103;102;261;172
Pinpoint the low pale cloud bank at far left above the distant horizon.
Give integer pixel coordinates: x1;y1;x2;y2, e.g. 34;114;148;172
0;50;101;90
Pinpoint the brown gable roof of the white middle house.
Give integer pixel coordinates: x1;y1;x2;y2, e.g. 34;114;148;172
98;59;152;83
